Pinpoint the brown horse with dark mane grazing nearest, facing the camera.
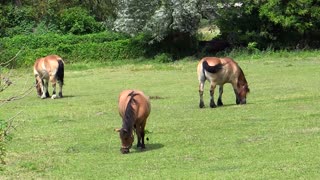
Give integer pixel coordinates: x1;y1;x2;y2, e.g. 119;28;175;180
115;90;151;154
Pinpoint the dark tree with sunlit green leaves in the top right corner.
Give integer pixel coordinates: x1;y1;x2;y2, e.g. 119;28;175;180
212;0;320;49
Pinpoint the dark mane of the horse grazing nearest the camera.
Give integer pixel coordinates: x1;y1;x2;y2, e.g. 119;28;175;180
123;91;138;132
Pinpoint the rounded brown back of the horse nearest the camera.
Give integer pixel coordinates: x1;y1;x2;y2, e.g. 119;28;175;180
118;90;151;119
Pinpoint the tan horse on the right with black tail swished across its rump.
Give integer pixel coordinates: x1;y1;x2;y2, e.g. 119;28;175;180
197;57;250;108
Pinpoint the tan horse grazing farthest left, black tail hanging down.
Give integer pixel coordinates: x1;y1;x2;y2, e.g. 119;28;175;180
33;55;64;99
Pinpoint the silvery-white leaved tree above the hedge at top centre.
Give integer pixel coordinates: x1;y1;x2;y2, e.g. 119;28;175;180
114;0;201;42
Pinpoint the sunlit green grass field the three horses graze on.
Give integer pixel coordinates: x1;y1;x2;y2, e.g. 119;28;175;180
0;52;320;179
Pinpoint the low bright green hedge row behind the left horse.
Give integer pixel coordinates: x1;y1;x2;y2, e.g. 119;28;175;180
0;32;145;67
